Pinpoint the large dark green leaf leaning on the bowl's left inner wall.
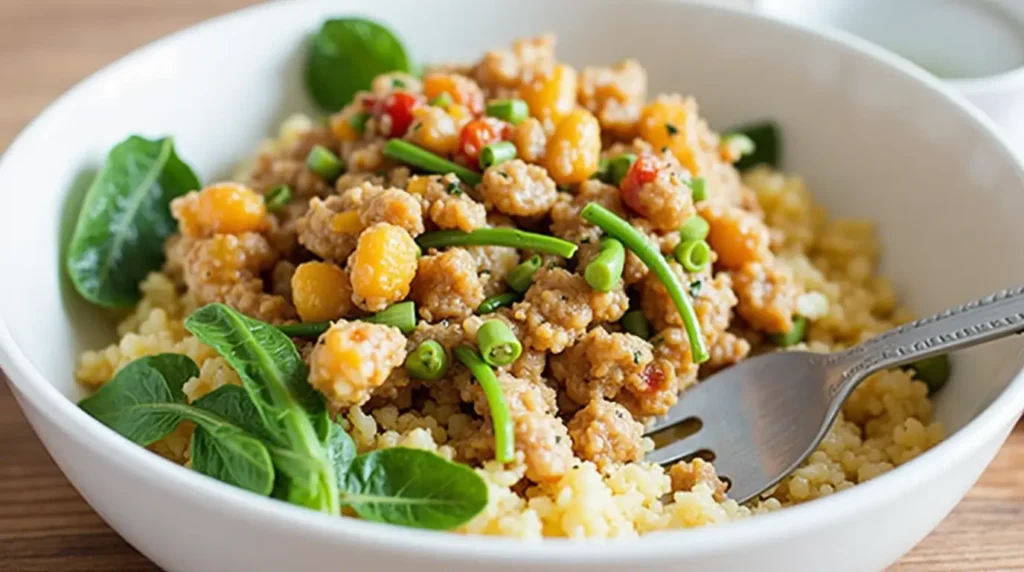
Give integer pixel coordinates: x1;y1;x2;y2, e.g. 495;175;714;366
66;136;200;308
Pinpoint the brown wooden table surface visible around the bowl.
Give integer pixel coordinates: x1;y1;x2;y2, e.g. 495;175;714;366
0;0;1024;572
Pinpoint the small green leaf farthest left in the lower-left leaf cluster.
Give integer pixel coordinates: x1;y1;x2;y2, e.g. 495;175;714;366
78;354;199;446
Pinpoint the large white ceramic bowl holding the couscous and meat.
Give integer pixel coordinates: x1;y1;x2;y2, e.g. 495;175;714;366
0;0;1024;572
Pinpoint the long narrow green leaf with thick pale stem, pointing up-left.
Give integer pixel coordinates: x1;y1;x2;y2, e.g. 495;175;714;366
185;304;339;514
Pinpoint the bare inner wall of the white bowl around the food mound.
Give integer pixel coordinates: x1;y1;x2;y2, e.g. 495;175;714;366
0;0;1024;460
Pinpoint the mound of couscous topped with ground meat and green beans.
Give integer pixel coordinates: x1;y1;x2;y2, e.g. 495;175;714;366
66;22;943;538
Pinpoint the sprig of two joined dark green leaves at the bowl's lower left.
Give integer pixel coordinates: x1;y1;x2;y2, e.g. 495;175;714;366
79;354;273;495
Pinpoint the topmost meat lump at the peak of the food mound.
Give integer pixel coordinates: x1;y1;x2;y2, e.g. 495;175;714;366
473;34;555;96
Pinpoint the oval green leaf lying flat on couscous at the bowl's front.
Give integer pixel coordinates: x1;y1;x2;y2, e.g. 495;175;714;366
341;447;487;530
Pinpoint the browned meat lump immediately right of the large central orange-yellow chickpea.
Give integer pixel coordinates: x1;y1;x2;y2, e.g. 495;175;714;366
410;248;483;321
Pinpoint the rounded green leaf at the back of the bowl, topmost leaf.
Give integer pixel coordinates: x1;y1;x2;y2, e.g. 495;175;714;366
306;17;412;112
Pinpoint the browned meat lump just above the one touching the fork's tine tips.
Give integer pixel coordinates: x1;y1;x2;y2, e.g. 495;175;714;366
551;327;653;405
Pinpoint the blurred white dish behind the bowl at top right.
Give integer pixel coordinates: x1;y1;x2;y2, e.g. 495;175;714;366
754;0;1024;151
